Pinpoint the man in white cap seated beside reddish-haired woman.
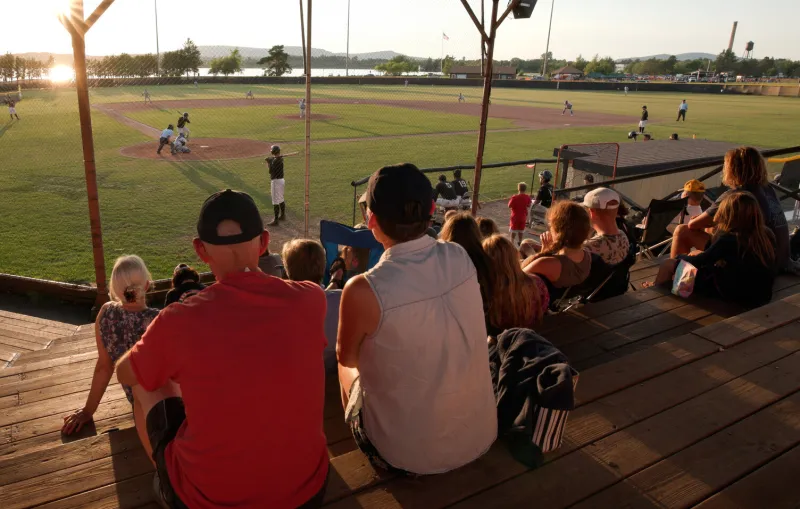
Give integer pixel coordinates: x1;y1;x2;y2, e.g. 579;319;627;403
583;187;631;265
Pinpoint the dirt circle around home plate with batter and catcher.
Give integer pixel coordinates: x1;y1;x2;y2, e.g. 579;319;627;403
120;138;272;161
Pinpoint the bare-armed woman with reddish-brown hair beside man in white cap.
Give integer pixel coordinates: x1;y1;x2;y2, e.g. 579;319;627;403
523;200;592;288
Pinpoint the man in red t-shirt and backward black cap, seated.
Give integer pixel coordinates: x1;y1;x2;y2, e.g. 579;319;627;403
117;189;328;508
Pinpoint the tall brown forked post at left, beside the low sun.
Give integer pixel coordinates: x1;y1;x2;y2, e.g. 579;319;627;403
64;0;113;308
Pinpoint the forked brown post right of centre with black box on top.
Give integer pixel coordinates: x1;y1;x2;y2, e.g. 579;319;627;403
461;0;537;215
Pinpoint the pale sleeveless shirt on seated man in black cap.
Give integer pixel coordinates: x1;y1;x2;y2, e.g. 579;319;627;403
358;235;497;474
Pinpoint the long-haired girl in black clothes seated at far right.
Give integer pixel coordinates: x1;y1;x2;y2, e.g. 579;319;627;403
655;191;777;307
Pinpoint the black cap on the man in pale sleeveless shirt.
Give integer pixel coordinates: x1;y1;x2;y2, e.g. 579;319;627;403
367;163;433;224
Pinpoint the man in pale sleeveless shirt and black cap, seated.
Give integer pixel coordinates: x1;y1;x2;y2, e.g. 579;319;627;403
336;164;497;474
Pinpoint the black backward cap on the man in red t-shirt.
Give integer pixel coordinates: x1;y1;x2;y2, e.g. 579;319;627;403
197;189;264;246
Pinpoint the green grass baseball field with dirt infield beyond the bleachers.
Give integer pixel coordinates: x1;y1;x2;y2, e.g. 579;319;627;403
0;84;800;282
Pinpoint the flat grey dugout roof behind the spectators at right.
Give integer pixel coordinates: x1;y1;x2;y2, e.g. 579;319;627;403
553;136;761;177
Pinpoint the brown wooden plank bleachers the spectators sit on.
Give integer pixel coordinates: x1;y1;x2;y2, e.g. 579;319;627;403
0;263;800;509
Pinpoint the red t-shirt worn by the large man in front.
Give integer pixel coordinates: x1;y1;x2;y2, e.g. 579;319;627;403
130;272;328;508
